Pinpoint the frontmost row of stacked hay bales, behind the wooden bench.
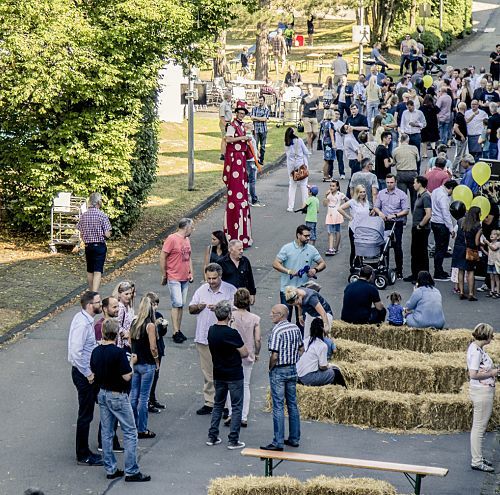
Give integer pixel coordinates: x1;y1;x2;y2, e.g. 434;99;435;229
297;385;500;431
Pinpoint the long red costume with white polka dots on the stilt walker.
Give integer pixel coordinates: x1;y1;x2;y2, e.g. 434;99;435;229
222;120;253;248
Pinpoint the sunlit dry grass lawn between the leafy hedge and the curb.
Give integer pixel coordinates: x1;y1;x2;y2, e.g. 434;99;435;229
0;112;284;334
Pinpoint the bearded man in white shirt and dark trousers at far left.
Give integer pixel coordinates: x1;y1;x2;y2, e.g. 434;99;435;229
68;291;103;466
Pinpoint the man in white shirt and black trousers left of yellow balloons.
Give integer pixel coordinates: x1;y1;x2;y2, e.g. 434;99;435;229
431;180;458;280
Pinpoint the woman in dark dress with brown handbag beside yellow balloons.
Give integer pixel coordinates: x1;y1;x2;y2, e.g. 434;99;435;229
451;206;481;301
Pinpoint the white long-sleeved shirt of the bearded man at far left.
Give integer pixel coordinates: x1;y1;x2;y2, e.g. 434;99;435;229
68;309;97;376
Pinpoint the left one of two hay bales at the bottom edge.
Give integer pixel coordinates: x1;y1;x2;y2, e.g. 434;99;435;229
208;476;304;495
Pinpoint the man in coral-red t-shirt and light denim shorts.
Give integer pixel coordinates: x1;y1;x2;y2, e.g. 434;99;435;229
160;218;193;344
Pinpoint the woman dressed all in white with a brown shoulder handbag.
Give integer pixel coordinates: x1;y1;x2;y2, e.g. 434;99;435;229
285;127;309;212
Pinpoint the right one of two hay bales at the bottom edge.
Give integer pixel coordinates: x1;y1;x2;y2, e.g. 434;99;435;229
304;476;396;495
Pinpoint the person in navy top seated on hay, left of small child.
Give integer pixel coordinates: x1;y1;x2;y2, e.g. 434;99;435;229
340;265;386;324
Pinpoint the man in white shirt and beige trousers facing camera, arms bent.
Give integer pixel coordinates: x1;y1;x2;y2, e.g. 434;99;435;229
189;263;236;415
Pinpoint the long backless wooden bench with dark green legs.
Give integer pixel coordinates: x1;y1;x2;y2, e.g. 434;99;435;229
241;448;448;495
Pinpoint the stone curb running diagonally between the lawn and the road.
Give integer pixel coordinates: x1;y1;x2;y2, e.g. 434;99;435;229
0;154;285;344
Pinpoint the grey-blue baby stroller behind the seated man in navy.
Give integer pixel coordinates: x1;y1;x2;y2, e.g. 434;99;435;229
348;216;396;290
